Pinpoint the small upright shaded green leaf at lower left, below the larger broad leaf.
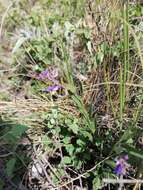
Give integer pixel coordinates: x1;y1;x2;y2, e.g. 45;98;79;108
6;158;16;177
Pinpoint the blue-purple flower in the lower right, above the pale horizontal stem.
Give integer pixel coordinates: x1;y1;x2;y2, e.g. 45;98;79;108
114;155;129;175
